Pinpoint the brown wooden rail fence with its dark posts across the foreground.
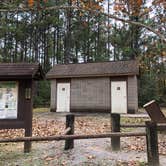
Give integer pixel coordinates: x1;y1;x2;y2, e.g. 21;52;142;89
0;114;166;166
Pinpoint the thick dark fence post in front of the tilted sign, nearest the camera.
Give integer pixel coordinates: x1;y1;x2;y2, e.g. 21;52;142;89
145;121;159;166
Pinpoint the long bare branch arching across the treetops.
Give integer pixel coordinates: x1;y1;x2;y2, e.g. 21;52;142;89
0;6;166;42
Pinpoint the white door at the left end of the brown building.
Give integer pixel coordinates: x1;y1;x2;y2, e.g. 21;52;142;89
57;83;70;112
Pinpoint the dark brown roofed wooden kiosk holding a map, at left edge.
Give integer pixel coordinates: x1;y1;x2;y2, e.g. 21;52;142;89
0;63;44;152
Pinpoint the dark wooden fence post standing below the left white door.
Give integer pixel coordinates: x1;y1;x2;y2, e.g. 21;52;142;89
64;114;75;150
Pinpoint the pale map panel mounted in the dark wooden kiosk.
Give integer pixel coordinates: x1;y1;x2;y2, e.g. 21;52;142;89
0;81;18;119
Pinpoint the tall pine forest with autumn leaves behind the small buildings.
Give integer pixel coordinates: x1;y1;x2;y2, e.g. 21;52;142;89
0;0;166;107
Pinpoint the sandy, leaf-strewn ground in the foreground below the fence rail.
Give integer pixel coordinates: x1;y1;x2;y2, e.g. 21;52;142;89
0;139;166;166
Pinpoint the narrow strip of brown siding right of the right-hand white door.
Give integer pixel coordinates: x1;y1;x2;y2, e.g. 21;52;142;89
128;76;138;113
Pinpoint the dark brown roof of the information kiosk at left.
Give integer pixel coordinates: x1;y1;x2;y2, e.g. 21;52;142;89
0;63;44;80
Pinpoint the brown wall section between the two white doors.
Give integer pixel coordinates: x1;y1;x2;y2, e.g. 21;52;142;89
70;77;110;111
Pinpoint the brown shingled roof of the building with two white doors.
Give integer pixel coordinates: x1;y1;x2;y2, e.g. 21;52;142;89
46;60;139;79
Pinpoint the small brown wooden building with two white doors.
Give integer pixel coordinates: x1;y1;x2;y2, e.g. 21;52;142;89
47;60;139;113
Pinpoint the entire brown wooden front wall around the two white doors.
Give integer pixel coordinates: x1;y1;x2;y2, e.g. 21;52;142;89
50;76;138;113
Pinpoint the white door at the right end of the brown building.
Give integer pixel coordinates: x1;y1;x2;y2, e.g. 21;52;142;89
111;81;127;114
